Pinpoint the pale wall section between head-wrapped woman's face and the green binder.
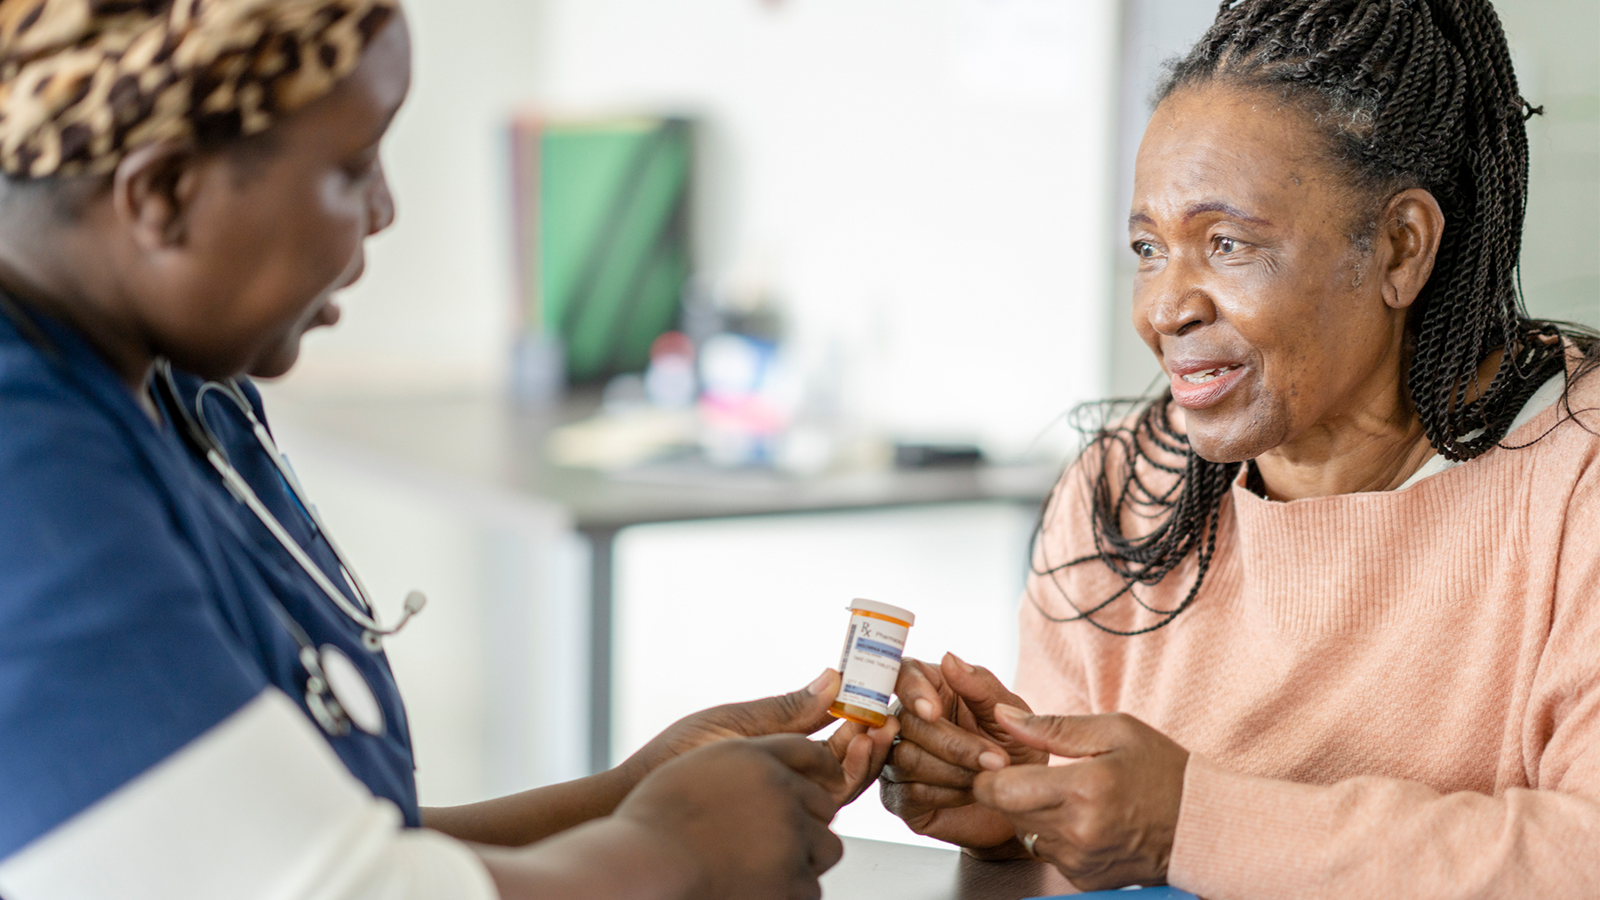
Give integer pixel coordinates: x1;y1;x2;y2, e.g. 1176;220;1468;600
288;0;553;394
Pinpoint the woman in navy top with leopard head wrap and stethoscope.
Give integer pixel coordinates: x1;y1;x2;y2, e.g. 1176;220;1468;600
0;0;893;900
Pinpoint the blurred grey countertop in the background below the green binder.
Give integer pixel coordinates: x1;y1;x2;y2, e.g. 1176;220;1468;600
266;388;1058;532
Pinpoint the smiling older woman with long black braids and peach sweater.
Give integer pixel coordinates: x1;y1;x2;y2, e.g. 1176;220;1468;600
883;0;1600;898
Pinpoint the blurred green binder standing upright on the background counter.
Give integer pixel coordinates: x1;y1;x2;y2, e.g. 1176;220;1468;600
512;119;693;383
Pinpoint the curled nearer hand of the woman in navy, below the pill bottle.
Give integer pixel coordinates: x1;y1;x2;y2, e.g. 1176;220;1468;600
616;735;845;900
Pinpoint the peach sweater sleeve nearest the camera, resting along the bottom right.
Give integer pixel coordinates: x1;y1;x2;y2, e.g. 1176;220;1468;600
1170;454;1600;900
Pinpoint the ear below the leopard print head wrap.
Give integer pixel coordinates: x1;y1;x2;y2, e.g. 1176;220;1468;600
112;139;202;253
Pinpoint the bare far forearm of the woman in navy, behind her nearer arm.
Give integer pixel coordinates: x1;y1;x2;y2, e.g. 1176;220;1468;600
422;767;638;847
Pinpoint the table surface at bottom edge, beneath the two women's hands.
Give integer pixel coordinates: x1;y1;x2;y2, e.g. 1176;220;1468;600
822;838;1075;900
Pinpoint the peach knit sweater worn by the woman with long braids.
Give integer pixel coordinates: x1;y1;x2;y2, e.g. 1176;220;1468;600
1018;365;1600;900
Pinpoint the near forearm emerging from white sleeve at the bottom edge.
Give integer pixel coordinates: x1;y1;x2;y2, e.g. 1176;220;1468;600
477;818;698;900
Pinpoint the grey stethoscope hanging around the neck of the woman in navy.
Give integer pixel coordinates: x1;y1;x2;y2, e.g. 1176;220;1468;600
152;360;427;737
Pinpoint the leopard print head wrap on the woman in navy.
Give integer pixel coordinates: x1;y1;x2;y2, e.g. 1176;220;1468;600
0;0;398;179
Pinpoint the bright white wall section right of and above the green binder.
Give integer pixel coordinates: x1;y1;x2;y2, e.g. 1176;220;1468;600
541;0;1115;452
